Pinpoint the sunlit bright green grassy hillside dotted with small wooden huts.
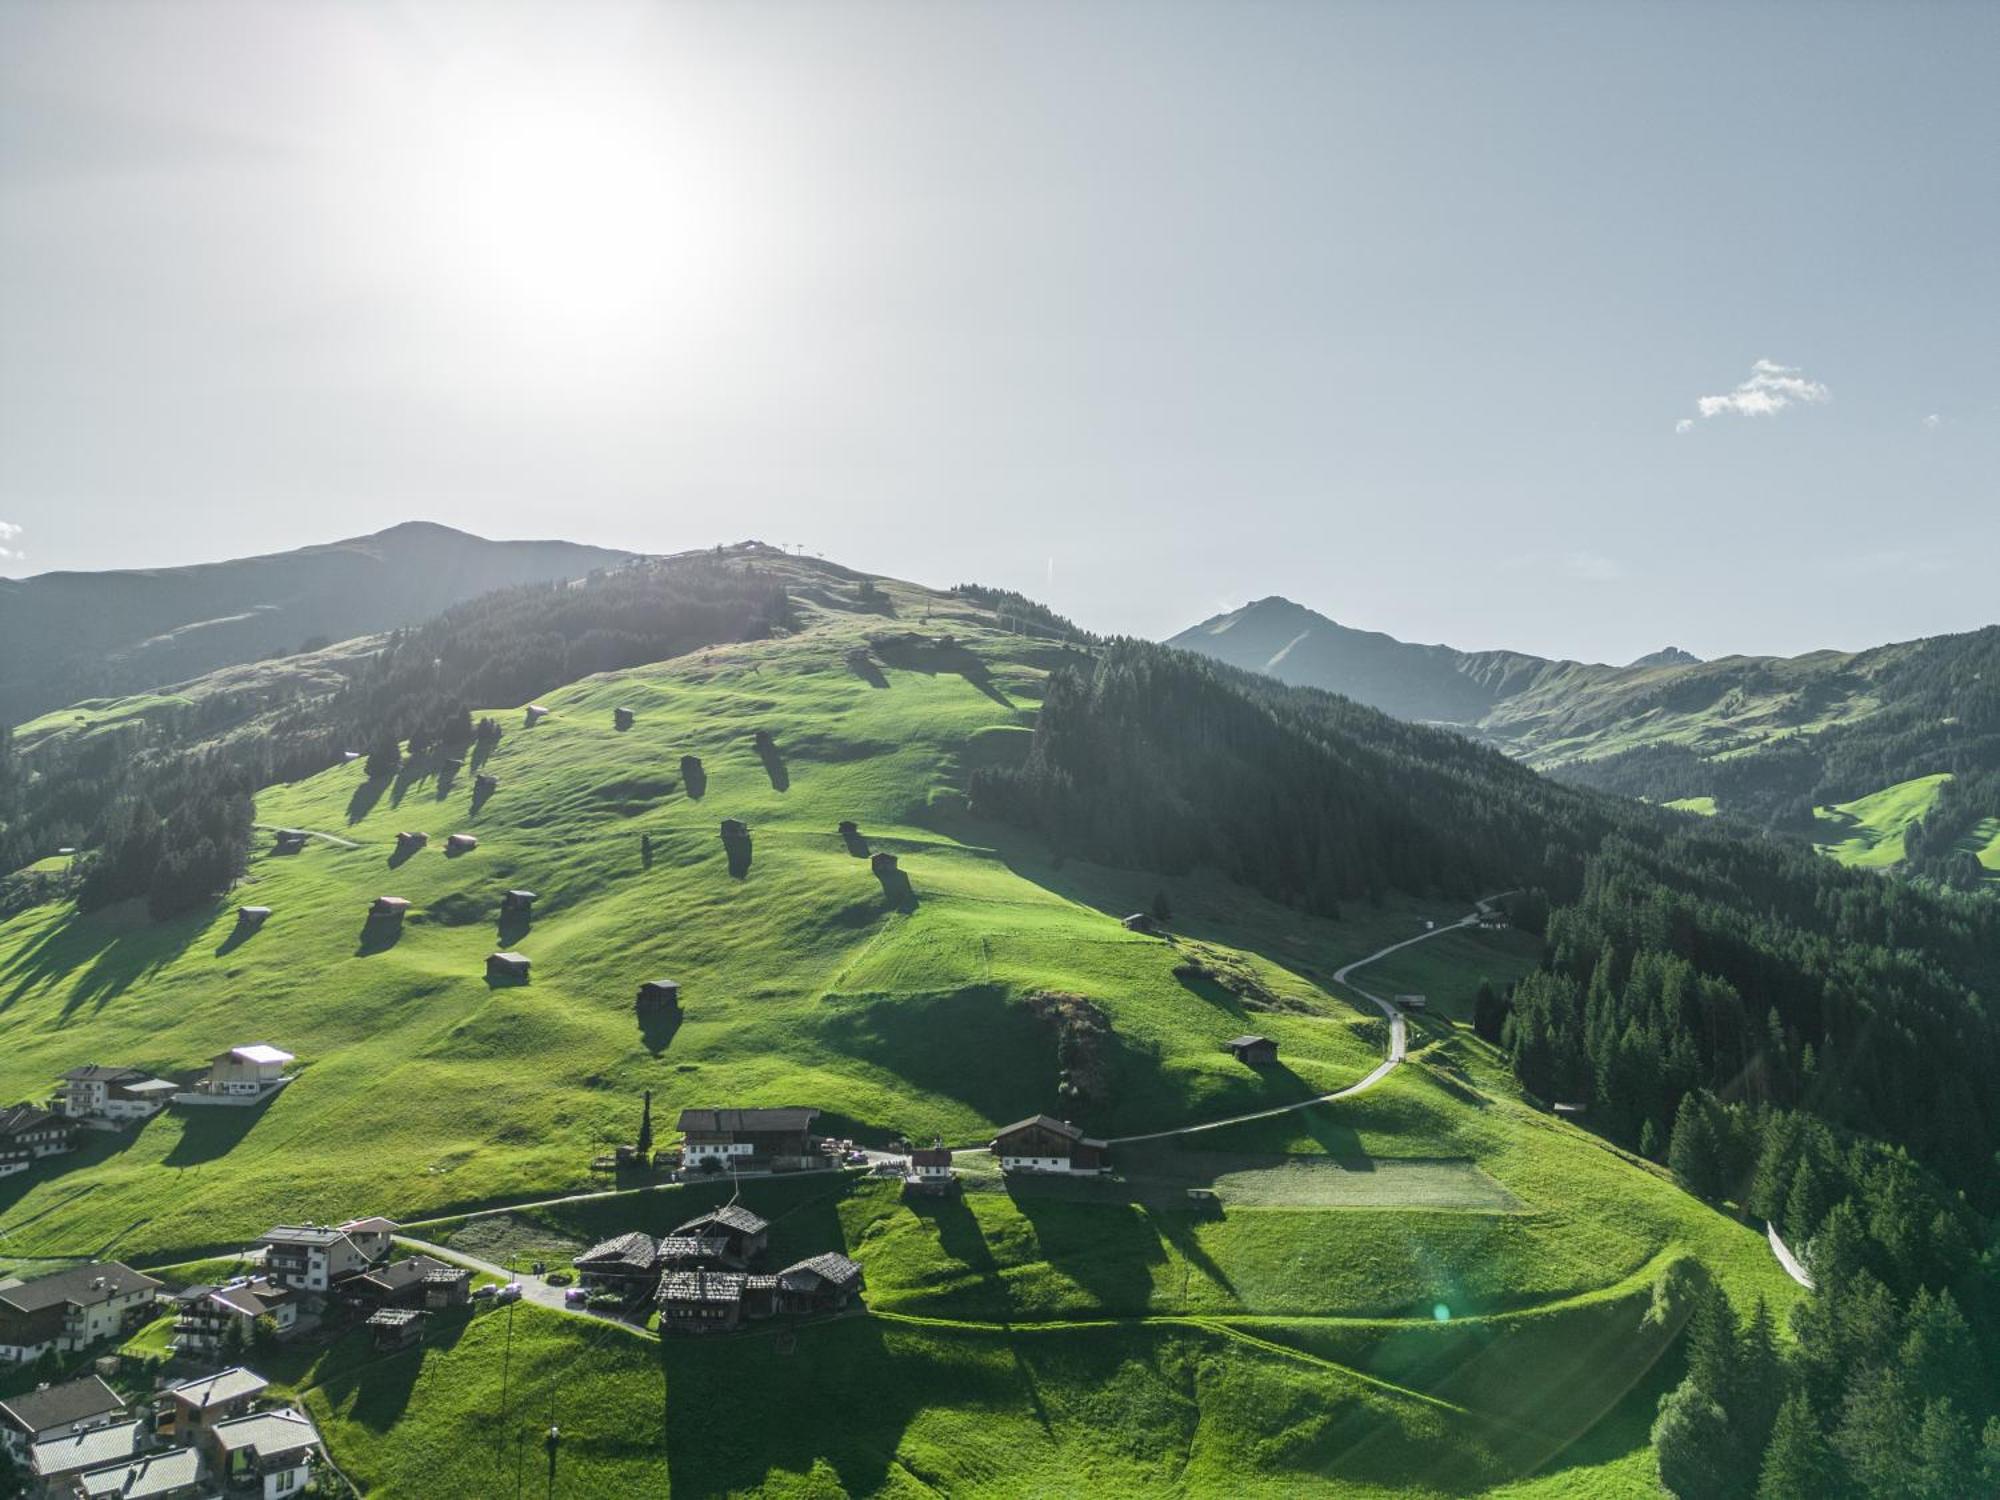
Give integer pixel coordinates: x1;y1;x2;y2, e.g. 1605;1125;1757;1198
0;562;1832;1496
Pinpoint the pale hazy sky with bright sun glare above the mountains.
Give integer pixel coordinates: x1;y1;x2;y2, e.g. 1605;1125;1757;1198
0;0;2000;660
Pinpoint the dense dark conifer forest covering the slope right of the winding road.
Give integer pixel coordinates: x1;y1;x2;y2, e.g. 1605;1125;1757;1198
972;642;2000;1500
